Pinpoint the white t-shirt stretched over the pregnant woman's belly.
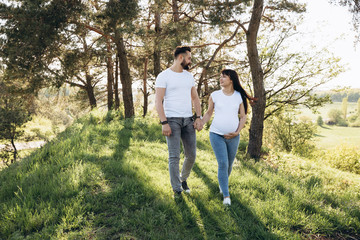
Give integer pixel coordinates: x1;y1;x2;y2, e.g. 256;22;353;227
210;90;243;135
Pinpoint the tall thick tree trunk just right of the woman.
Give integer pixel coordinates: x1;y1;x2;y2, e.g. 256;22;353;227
246;0;266;159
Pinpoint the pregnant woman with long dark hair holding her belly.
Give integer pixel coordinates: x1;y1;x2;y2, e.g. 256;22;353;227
202;69;256;205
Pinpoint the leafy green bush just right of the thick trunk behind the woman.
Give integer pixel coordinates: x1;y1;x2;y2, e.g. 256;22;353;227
265;113;316;156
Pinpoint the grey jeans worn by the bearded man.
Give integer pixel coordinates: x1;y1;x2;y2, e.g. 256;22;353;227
166;117;196;191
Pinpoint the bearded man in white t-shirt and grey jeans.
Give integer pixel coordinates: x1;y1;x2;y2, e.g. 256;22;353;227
155;47;203;196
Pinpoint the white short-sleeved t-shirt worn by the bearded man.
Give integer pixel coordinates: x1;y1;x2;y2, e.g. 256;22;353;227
155;68;195;117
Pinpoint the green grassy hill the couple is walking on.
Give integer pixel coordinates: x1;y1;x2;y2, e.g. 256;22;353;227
0;112;360;239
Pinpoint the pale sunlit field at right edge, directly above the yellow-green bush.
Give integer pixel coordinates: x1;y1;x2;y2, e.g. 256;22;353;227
315;125;360;150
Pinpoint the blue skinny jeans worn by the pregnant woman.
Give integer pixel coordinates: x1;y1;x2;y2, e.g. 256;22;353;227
210;132;240;197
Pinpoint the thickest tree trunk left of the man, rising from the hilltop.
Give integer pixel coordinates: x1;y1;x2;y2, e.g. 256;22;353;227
115;35;135;118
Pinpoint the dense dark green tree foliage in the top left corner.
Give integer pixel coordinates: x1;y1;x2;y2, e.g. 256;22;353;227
0;0;84;90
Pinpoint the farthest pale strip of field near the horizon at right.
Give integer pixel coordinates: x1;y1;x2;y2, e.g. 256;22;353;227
300;102;357;120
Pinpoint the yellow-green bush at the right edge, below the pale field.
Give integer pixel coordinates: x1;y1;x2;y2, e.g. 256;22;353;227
319;144;360;174
